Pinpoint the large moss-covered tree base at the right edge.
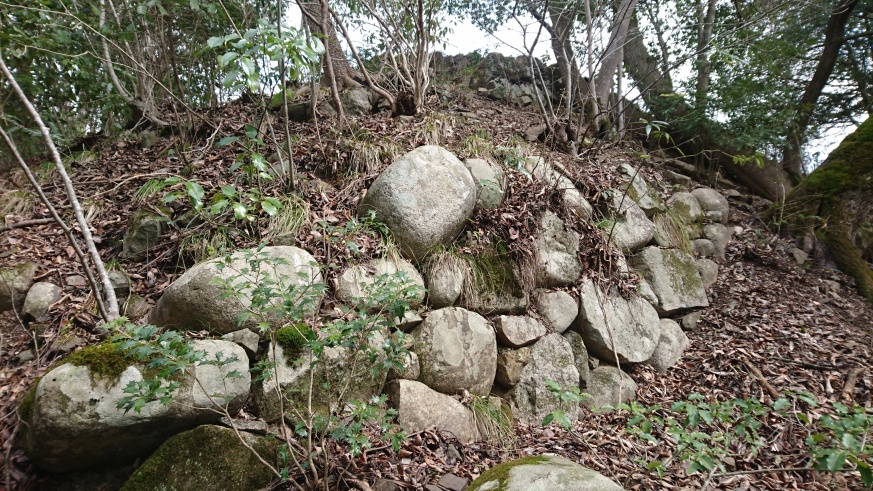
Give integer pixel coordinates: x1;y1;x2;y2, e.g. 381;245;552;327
768;119;873;302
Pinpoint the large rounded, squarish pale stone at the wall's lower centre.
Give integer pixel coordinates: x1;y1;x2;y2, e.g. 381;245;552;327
412;307;497;396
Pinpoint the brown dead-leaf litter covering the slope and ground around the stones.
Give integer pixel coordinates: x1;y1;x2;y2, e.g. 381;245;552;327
0;91;873;490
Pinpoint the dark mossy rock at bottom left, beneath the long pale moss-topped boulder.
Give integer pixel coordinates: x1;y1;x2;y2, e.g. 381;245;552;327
121;425;281;491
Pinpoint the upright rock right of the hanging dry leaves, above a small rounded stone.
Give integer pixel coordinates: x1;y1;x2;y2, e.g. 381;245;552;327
534;210;582;288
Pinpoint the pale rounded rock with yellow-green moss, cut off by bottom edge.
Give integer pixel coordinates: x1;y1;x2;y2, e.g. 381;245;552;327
467;455;623;491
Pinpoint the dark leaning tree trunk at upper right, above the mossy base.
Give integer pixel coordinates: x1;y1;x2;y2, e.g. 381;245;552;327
782;0;858;179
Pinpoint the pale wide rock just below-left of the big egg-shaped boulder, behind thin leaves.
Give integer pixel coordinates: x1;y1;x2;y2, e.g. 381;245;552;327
336;258;425;310
